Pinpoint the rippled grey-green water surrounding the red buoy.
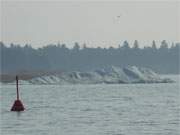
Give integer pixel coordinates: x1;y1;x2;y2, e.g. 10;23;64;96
0;75;180;135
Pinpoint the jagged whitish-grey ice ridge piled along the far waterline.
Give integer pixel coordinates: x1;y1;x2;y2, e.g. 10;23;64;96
27;66;173;84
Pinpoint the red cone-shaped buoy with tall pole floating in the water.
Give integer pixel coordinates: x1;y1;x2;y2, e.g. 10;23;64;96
11;76;24;112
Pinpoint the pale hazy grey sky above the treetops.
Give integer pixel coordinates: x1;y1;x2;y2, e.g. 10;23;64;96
0;1;180;47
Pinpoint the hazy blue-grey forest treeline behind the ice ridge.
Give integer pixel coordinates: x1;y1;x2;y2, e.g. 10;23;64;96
0;40;180;74
